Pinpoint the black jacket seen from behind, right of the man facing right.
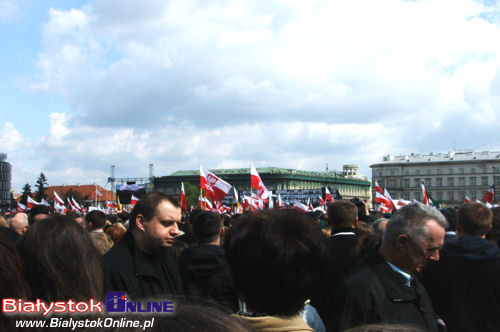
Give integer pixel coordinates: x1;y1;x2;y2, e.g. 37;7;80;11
179;244;238;312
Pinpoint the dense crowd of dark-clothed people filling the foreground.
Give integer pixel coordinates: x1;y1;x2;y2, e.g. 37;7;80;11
0;192;500;331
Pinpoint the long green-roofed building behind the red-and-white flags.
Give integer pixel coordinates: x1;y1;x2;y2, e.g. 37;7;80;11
153;165;371;205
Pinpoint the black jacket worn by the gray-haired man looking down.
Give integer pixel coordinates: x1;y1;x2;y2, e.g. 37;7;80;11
338;252;438;331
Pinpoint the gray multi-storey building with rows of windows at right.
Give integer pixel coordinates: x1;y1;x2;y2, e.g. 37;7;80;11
370;151;500;207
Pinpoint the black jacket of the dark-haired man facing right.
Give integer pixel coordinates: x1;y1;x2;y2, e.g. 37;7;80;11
103;231;182;300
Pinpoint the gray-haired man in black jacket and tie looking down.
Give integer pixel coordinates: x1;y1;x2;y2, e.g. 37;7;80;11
338;203;447;331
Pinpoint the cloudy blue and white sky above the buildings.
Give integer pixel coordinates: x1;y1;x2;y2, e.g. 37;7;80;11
0;0;500;192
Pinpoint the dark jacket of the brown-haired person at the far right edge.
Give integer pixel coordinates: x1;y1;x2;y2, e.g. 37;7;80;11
423;236;500;332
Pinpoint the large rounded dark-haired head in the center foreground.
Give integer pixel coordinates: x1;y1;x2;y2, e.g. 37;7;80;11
225;210;328;316
